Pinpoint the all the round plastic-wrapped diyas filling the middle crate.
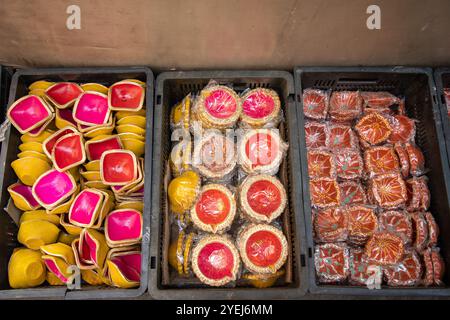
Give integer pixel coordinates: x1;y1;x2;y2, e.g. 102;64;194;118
167;81;290;288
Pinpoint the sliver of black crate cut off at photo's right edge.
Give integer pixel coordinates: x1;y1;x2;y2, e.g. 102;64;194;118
434;68;450;170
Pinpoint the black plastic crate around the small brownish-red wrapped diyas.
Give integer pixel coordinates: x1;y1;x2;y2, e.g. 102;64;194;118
294;67;450;296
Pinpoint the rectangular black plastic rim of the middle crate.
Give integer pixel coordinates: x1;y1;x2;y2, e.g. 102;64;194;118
148;70;308;300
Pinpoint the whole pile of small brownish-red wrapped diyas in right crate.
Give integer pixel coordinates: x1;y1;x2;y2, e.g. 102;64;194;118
303;88;444;287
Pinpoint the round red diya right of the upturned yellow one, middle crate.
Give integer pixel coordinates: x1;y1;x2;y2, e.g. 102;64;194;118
191;184;236;233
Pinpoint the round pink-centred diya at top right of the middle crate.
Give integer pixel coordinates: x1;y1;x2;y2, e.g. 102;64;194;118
240;88;281;128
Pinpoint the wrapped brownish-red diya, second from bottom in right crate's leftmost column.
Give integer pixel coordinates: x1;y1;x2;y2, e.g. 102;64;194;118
313;208;348;242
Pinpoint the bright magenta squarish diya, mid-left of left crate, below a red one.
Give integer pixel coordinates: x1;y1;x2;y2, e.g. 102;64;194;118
32;169;77;209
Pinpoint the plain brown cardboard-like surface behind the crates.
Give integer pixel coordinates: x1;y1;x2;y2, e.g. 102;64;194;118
0;0;450;70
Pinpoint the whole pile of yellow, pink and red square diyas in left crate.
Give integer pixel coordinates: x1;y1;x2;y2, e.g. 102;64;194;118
7;79;147;288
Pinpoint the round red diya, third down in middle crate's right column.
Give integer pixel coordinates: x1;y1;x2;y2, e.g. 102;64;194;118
239;175;287;223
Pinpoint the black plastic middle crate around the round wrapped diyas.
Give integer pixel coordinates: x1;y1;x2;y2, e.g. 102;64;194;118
148;71;307;300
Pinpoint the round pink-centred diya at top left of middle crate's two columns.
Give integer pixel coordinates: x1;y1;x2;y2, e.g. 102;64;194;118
191;84;242;129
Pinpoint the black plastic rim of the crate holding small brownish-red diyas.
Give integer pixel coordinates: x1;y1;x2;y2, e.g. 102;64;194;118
294;66;450;297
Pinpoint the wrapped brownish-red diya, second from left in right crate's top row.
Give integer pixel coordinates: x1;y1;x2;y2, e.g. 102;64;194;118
329;91;363;121
